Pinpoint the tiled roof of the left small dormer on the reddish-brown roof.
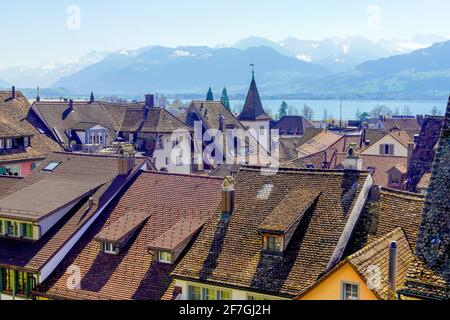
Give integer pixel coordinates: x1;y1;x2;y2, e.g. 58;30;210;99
95;211;150;246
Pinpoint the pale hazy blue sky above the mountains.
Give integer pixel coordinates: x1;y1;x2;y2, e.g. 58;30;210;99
0;0;450;68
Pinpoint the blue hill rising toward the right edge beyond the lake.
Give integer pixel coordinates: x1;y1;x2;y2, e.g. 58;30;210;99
306;41;450;99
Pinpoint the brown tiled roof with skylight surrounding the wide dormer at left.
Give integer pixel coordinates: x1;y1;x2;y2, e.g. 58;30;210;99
0;153;138;272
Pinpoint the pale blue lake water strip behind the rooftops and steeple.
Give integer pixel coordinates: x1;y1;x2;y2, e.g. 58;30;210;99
230;100;447;120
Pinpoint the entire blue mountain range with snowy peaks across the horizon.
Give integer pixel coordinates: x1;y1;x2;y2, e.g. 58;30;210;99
0;36;450;99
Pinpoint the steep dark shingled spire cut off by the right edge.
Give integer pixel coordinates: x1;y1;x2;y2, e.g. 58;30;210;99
416;98;450;281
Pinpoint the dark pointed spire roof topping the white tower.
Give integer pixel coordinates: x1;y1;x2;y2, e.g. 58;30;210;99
238;64;272;121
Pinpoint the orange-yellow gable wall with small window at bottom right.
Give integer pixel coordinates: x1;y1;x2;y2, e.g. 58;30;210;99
298;263;378;300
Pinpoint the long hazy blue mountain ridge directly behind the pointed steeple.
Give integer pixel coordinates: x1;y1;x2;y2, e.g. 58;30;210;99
55;46;330;94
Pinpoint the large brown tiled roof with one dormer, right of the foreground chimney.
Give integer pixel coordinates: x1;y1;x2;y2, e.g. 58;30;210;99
172;168;368;297
